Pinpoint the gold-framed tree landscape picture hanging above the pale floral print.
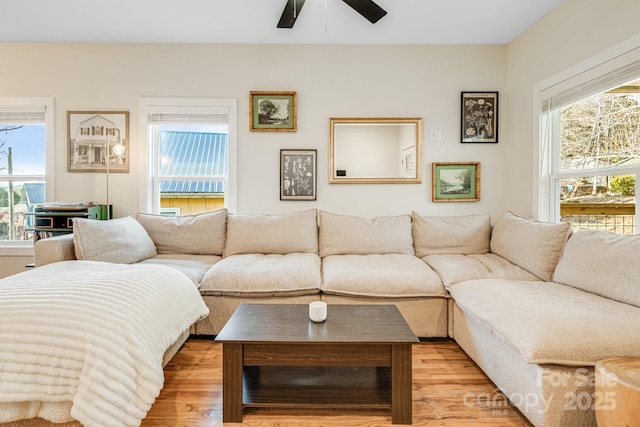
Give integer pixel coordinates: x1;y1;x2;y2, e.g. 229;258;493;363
249;91;297;132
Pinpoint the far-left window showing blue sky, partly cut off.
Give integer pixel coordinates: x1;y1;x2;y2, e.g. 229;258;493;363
0;98;54;247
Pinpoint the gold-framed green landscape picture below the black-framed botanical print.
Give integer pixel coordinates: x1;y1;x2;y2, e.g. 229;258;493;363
431;162;480;202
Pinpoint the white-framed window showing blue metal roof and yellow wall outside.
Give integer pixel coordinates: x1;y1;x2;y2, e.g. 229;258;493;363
140;98;236;215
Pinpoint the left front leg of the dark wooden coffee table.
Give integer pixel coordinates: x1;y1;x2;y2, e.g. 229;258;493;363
222;343;242;423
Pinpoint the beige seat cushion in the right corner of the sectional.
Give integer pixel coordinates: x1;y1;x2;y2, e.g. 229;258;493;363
422;254;540;287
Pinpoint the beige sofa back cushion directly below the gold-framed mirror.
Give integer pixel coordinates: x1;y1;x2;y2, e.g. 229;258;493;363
320;211;414;257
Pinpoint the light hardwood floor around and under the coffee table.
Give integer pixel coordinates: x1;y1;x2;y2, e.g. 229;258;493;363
142;339;531;427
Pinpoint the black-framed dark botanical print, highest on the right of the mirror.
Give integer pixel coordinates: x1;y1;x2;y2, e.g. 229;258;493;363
460;92;498;143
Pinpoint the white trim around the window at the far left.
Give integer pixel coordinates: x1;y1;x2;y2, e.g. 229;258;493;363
0;97;54;256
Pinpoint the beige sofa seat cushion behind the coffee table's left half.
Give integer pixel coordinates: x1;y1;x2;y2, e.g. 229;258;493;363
200;253;320;297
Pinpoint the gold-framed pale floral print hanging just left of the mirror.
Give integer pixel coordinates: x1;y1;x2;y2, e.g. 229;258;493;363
280;150;317;200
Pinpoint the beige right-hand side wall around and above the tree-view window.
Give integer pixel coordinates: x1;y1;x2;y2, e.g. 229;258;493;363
506;0;640;216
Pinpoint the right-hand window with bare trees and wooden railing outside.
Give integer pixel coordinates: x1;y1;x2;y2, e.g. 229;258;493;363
539;48;640;234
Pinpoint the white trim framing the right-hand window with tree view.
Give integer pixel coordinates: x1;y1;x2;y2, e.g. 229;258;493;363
531;35;640;223
